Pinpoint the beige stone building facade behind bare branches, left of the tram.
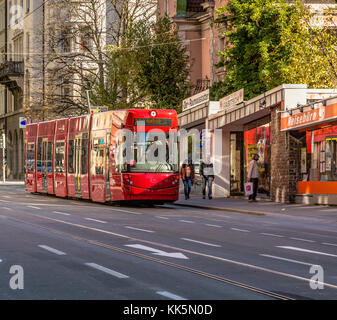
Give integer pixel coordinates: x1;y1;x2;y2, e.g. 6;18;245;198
0;0;121;179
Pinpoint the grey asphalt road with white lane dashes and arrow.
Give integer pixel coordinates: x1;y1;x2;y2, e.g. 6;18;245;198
0;185;337;300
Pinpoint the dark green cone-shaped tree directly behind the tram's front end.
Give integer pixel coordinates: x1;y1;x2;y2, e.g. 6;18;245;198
138;16;192;110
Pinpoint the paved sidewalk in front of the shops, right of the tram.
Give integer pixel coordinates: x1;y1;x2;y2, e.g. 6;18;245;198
174;194;337;221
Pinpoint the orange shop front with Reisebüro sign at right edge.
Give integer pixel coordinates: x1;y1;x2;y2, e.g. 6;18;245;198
281;97;337;204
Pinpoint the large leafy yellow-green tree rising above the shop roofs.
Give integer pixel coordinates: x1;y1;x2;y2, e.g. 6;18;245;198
211;0;337;99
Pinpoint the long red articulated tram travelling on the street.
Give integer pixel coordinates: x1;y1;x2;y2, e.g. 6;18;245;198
26;109;179;203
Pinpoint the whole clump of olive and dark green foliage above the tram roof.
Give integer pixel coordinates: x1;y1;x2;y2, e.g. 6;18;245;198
91;17;191;111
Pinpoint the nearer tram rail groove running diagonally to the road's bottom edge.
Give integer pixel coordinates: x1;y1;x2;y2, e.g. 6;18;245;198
1;215;294;300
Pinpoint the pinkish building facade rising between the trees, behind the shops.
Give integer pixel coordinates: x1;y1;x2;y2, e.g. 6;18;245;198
158;0;228;94
